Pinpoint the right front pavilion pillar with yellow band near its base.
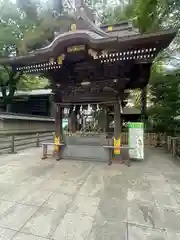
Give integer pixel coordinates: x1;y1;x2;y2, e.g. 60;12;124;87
114;99;121;159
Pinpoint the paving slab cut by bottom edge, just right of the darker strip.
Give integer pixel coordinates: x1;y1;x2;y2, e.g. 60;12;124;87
128;225;166;240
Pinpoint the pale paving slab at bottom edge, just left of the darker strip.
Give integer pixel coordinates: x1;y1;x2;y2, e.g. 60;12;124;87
52;213;93;240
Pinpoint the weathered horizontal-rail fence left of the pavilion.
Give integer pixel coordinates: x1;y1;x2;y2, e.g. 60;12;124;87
0;130;54;154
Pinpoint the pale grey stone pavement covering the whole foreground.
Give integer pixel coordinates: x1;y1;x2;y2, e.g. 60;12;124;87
0;149;180;240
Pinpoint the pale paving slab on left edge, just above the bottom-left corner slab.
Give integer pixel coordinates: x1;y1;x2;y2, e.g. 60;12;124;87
0;204;38;231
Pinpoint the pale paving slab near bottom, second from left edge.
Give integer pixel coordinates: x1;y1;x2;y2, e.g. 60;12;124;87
21;207;64;238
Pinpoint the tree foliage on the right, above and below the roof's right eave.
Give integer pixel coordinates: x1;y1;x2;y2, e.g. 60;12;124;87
103;0;180;133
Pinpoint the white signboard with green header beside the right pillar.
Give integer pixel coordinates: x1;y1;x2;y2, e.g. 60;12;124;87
128;122;144;160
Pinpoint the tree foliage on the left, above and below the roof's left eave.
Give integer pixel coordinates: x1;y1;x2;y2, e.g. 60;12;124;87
0;0;70;108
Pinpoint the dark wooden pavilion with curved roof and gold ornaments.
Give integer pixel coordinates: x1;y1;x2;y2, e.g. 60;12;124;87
0;6;176;162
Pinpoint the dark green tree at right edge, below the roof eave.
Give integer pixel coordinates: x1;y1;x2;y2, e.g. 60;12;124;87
148;51;180;134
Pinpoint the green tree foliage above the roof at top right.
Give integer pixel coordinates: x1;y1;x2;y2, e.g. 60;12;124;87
102;0;180;33
